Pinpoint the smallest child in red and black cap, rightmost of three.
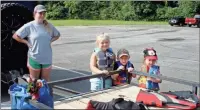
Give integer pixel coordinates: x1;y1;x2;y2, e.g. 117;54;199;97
138;48;162;91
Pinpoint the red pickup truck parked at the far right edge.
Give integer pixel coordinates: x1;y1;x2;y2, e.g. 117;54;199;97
185;14;200;28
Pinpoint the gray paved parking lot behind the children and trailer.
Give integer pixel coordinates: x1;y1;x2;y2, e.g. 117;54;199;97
0;25;200;107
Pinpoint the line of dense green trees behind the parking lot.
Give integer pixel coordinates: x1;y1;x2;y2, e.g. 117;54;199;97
43;0;200;21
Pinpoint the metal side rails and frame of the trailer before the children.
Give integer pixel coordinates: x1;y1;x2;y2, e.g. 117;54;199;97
19;71;200;109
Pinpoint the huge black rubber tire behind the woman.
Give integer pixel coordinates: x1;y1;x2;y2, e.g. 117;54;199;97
1;3;33;72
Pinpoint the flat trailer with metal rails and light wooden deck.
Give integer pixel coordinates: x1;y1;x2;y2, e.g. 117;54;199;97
1;71;200;109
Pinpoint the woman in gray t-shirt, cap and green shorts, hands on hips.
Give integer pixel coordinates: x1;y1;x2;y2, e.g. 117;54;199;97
13;5;60;81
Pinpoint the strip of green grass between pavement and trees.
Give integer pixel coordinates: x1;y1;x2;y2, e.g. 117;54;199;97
49;20;168;26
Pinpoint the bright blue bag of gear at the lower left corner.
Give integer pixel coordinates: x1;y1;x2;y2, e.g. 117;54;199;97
8;80;54;110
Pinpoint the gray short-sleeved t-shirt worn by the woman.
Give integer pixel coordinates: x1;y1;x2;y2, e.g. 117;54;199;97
16;21;60;64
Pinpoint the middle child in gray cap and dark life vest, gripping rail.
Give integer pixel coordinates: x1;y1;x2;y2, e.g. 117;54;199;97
112;49;136;86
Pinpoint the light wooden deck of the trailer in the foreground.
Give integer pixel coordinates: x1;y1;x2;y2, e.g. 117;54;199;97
54;85;166;109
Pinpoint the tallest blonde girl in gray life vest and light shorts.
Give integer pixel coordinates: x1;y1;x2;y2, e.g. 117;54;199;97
90;33;115;91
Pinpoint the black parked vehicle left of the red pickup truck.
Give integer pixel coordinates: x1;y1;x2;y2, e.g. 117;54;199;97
169;16;185;26
